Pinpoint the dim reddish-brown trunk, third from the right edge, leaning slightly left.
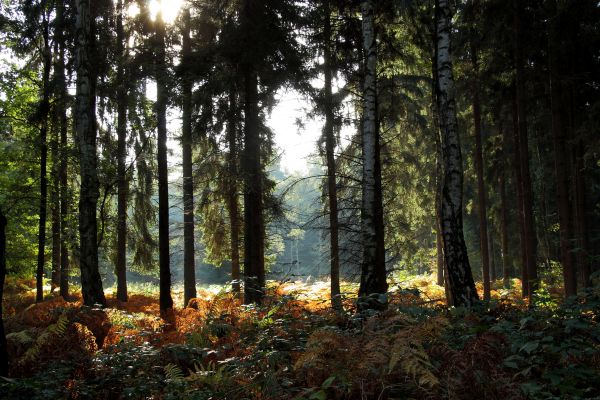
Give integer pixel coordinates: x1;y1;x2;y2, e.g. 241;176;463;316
514;0;538;299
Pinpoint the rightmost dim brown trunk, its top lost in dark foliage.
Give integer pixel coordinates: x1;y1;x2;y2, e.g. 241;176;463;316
574;138;592;287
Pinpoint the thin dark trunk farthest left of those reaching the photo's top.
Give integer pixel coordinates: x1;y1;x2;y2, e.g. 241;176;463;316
35;10;52;302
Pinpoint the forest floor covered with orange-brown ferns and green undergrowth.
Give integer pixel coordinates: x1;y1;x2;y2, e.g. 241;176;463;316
0;276;600;400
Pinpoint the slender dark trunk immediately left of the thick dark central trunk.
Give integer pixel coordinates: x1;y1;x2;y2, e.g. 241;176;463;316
227;87;241;296
